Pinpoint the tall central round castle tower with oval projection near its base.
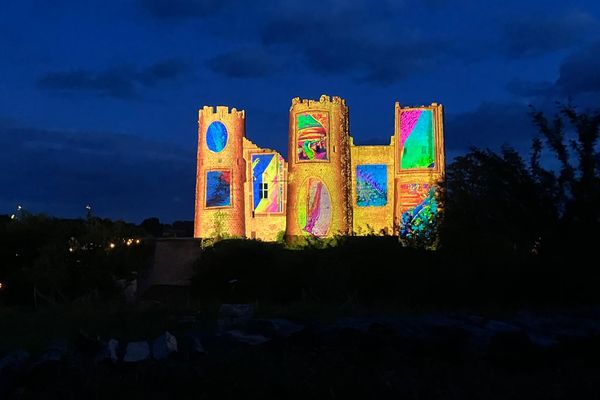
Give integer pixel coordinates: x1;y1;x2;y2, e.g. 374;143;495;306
286;95;352;238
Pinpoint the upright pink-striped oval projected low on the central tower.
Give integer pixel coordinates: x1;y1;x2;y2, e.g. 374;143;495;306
298;177;331;237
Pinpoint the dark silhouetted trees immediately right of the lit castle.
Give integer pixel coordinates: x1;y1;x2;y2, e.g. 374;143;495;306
440;106;600;257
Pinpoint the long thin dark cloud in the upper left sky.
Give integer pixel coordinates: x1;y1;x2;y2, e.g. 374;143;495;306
36;59;188;99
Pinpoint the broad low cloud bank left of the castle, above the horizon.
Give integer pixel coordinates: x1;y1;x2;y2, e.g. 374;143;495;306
0;121;195;222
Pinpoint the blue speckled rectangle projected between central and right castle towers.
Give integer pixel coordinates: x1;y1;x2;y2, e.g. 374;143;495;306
356;164;387;207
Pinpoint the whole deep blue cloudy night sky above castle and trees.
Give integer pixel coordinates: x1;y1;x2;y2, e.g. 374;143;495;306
0;0;600;222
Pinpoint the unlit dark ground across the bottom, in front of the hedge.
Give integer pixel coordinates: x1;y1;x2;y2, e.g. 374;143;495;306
0;309;600;399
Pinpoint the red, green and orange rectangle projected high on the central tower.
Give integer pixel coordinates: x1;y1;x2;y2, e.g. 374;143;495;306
296;112;329;161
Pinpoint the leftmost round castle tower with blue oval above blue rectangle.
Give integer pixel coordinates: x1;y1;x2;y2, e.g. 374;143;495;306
194;106;246;237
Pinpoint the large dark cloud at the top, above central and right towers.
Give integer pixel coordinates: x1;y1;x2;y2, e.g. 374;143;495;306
260;2;453;85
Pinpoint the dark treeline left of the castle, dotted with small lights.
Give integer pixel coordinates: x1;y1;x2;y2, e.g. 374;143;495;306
0;214;193;305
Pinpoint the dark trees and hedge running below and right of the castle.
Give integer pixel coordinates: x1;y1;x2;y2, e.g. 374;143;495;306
194;106;600;309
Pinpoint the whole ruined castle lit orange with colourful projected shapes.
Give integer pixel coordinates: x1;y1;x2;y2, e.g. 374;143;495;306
194;95;444;241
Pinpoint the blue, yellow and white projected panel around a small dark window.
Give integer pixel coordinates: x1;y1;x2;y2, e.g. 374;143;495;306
252;153;284;213
